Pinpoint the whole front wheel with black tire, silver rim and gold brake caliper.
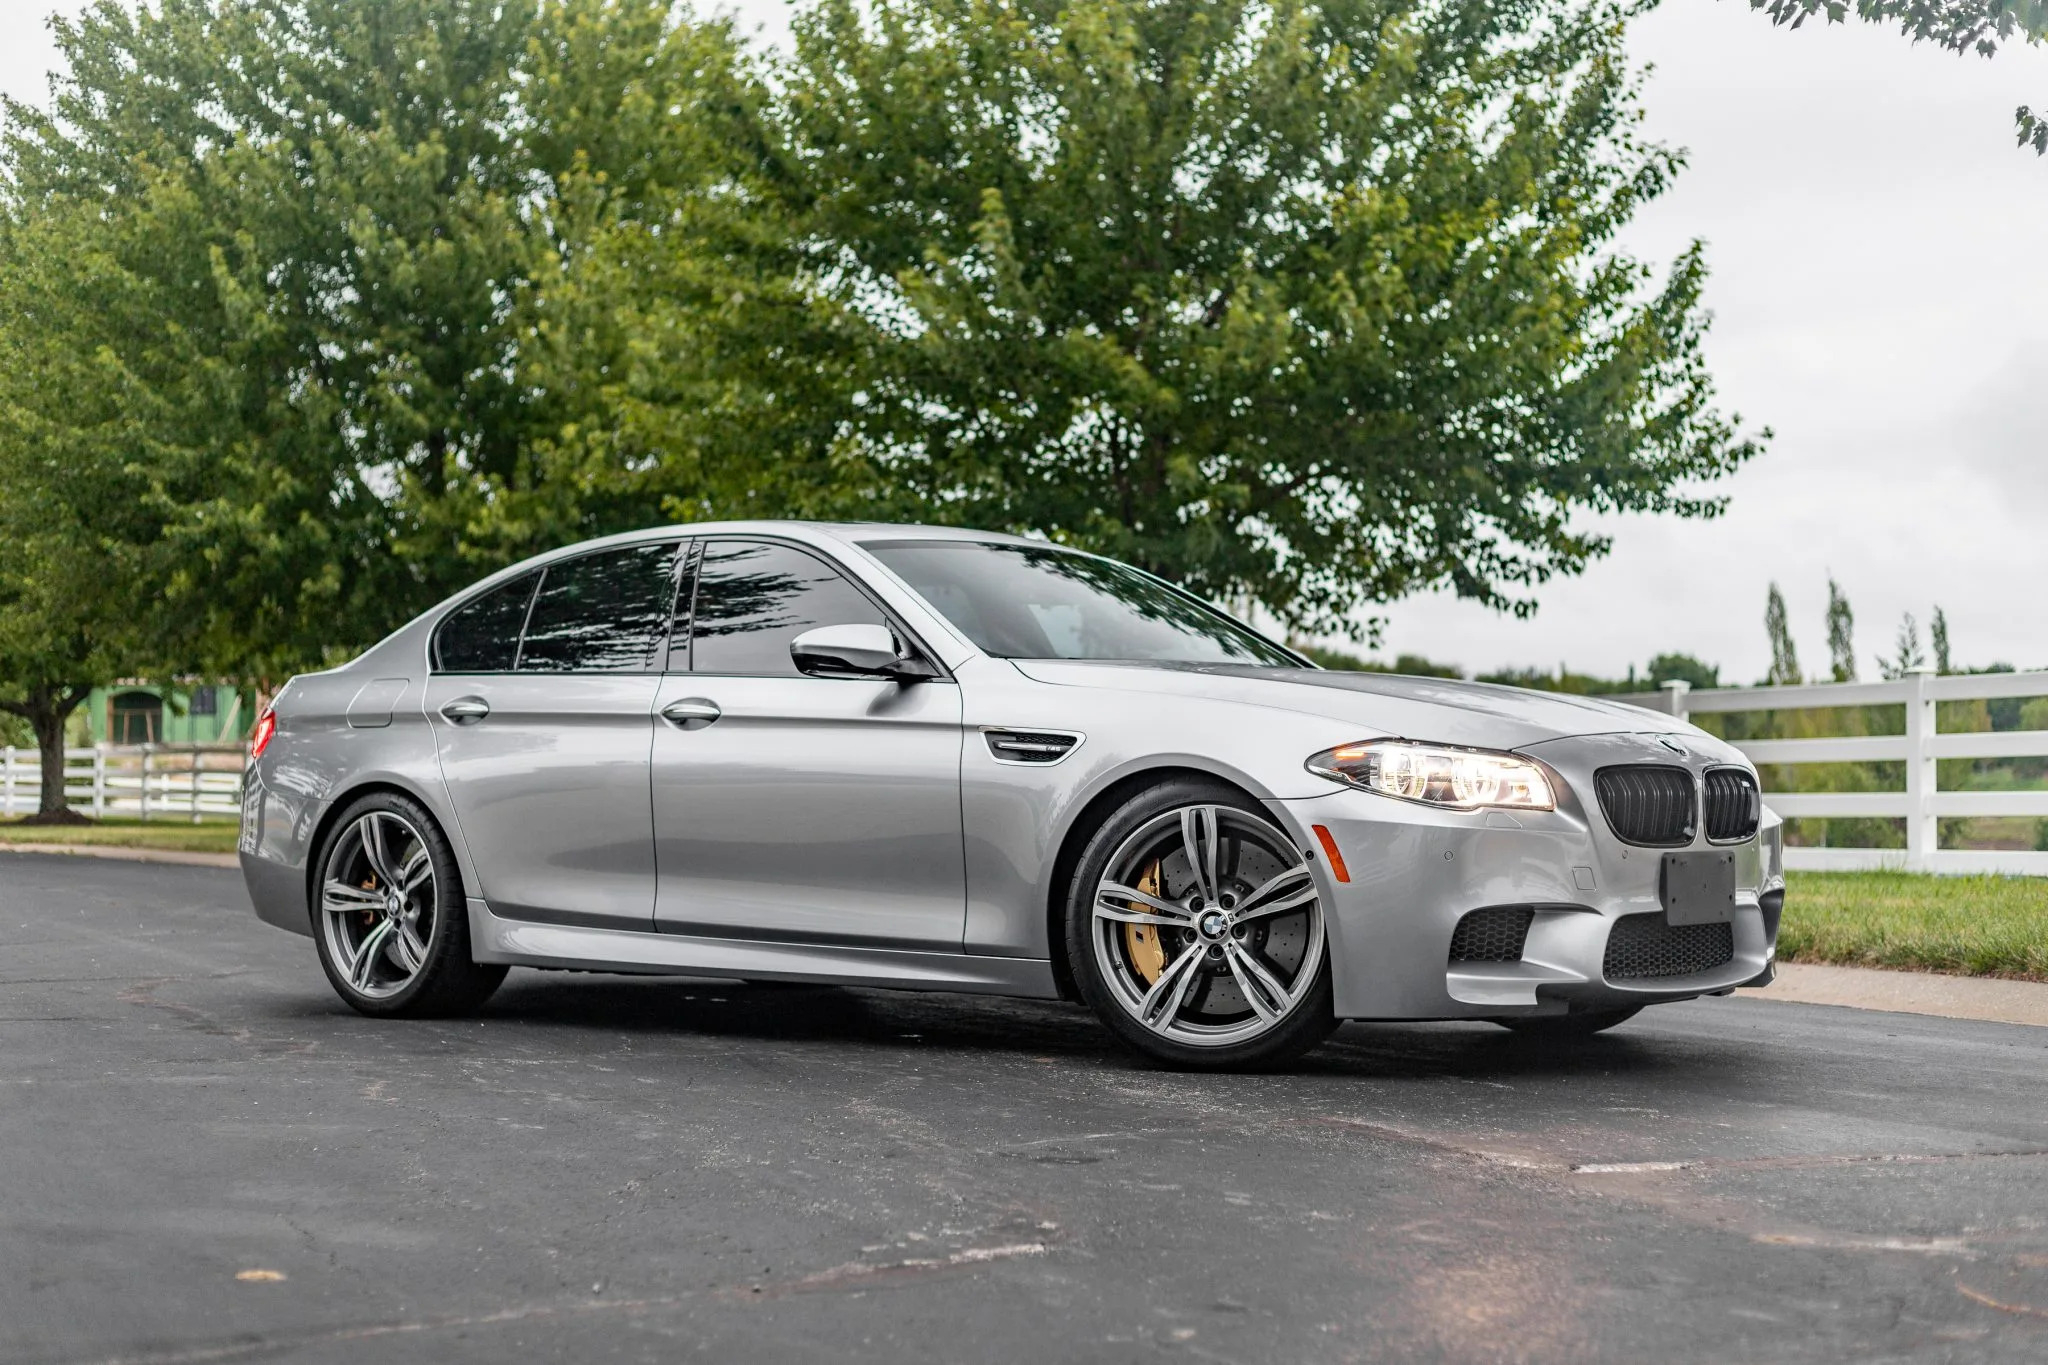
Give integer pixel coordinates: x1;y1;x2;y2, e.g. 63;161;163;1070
1067;782;1337;1070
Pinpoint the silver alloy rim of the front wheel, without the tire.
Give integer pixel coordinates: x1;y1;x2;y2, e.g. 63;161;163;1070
1090;804;1323;1048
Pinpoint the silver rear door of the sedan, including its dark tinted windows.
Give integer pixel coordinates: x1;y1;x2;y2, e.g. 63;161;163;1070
426;542;678;929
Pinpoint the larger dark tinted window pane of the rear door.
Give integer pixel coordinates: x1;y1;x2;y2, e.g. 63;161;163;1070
518;542;676;673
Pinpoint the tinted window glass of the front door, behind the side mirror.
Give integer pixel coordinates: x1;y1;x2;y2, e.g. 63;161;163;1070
690;540;889;677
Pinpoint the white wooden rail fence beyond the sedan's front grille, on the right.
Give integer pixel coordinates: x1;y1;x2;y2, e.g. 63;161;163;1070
1616;669;2048;876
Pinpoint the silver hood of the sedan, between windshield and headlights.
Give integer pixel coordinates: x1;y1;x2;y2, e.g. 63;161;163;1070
1012;659;1696;749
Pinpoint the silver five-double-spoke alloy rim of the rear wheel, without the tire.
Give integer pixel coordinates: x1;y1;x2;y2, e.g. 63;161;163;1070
319;810;440;1001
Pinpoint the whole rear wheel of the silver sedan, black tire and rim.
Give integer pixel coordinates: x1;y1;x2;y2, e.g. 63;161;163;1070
313;792;506;1017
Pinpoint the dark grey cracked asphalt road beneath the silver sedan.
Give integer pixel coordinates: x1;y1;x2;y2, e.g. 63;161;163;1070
12;853;2048;1365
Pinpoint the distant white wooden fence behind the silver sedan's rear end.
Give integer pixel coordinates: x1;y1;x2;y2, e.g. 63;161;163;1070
0;745;248;825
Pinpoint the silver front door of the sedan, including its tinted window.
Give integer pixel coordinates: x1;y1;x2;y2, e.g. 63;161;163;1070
653;538;967;952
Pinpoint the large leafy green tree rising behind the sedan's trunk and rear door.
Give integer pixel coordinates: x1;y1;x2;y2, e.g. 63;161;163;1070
4;0;770;679
